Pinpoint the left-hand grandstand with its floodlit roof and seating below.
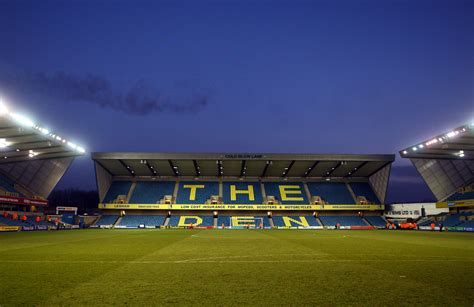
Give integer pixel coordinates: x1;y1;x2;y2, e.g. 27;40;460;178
0;102;85;227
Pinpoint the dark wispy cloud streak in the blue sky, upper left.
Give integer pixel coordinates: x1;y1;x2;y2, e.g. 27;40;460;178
0;72;210;115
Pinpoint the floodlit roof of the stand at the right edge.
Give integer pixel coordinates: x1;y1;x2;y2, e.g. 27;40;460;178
400;123;474;201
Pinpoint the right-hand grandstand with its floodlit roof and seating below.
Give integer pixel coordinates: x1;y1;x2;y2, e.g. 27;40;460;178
400;123;474;230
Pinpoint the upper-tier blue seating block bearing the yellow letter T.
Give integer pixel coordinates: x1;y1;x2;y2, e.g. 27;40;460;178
176;181;219;204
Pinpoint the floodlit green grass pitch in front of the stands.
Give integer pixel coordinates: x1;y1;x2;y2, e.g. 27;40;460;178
0;230;474;306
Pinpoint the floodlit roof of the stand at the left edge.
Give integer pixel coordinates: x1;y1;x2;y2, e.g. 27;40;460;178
0;102;85;198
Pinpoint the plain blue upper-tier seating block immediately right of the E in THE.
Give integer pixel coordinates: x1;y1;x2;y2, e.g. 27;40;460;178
308;182;356;205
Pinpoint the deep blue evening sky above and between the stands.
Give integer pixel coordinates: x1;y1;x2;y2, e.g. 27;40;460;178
0;0;474;205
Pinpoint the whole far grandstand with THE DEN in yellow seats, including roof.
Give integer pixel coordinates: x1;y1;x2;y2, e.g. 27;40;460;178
92;153;394;228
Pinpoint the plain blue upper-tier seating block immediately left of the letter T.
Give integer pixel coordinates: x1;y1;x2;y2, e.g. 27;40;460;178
130;181;176;204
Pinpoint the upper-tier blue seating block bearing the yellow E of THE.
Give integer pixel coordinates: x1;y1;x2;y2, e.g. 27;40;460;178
264;182;309;205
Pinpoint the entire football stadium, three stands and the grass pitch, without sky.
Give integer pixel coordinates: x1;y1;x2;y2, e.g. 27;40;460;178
0;103;474;306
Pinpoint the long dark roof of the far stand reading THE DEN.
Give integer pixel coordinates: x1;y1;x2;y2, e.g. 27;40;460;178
92;153;395;178
